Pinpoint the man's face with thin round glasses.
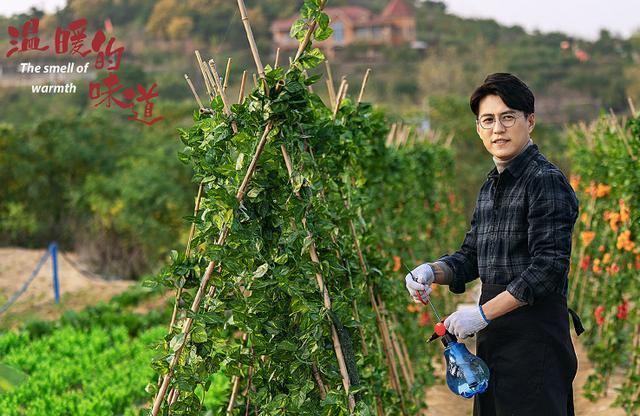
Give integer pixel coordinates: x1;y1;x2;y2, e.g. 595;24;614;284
476;95;536;160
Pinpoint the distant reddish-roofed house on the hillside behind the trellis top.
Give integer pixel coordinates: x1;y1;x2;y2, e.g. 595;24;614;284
271;0;416;56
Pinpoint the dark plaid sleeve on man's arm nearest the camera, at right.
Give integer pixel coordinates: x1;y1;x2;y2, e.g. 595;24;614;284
507;170;578;305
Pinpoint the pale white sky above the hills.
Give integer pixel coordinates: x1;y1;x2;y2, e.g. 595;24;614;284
0;0;640;40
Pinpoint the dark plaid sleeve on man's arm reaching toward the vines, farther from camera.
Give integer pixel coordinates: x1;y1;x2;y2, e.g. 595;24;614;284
437;204;479;293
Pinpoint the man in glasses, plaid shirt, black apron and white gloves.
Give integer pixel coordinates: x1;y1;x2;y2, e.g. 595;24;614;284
406;73;581;416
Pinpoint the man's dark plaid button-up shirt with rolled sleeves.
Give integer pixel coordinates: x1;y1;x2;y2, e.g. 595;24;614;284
438;144;578;304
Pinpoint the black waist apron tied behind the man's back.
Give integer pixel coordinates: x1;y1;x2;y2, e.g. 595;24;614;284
473;284;583;416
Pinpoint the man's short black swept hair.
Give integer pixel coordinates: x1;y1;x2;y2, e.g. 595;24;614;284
469;72;535;117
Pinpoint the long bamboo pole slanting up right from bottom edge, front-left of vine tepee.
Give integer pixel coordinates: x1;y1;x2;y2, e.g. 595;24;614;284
151;122;273;416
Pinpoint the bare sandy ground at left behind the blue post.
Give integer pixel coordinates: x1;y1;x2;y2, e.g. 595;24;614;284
0;248;135;327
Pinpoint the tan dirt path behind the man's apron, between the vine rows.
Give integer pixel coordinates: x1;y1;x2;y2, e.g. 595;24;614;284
423;282;625;416
